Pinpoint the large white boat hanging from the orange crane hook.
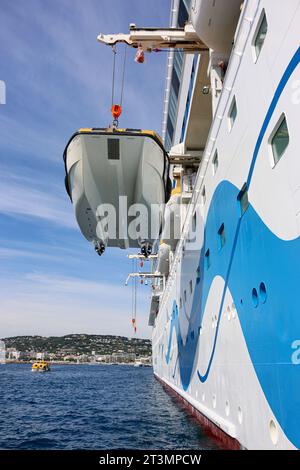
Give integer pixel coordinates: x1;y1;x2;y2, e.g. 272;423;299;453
64;128;170;256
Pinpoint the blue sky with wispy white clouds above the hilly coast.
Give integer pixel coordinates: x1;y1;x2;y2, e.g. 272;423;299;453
0;0;170;337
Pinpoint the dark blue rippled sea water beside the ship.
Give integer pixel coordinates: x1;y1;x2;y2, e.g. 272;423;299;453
0;364;218;449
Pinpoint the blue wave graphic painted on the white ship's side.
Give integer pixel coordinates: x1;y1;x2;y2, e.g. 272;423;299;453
165;48;300;447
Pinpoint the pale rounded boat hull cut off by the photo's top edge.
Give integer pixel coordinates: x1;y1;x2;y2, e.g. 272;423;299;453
191;0;242;56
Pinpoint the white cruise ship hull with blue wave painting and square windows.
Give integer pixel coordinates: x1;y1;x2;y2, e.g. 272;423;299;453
152;0;300;449
